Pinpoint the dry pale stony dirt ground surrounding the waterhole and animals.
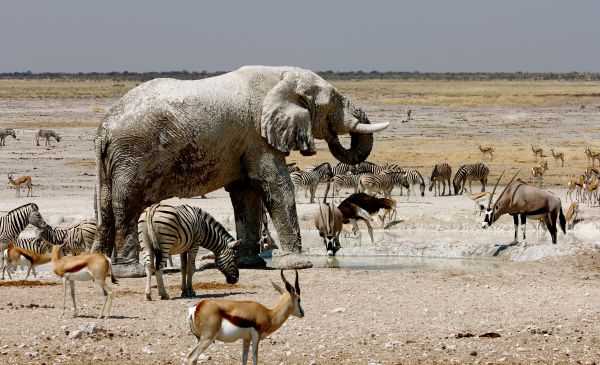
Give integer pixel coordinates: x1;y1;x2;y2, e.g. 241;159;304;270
0;87;600;364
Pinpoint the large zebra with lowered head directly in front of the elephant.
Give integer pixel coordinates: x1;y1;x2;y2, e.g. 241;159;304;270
138;204;240;300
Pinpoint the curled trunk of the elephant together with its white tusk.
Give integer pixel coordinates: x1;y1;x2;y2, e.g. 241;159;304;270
327;100;389;165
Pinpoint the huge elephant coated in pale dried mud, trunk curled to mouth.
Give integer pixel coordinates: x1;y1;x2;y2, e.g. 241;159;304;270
93;66;389;277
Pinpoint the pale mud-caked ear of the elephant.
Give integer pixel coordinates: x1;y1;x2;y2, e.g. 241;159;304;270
261;72;316;156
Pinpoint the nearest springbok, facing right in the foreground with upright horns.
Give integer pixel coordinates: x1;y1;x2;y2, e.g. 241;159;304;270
187;269;304;365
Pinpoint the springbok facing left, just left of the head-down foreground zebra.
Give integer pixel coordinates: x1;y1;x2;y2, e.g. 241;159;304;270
50;245;117;319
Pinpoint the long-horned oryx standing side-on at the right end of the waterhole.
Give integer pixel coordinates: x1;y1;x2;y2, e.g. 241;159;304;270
482;172;566;244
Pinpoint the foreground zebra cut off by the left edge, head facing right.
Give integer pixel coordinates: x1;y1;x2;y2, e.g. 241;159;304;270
0;203;47;280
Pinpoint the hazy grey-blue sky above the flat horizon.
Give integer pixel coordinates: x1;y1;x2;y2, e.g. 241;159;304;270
0;0;600;72
